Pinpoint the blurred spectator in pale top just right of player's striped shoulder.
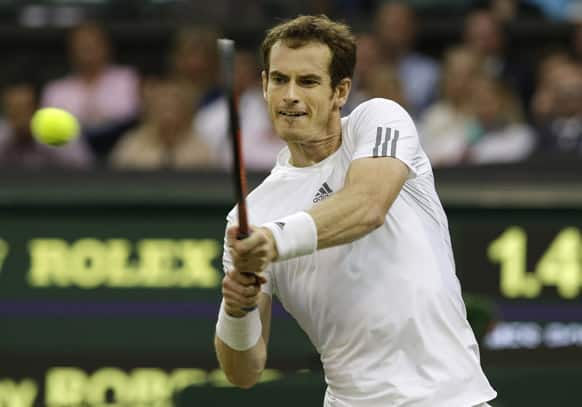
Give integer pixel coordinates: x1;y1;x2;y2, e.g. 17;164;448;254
419;47;482;167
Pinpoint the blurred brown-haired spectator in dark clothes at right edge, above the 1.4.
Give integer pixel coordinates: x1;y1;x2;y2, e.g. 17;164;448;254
534;61;582;155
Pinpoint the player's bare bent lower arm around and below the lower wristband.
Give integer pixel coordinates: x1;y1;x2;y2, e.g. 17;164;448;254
214;292;272;389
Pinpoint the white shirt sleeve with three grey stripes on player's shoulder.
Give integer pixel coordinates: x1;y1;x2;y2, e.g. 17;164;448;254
351;98;425;179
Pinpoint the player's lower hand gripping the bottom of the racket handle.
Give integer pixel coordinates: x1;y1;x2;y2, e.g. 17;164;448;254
222;269;267;318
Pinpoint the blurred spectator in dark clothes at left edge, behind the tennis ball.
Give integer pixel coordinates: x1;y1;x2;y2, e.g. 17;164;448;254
0;83;92;169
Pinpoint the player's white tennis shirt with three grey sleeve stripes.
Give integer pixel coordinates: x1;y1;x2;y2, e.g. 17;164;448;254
224;99;496;407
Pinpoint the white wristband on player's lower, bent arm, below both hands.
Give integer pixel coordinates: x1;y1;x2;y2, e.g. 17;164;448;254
216;301;263;351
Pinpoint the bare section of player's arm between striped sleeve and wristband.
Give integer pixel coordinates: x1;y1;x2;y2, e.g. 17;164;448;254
307;157;408;249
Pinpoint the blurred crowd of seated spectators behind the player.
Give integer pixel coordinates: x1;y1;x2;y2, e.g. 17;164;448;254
0;0;582;171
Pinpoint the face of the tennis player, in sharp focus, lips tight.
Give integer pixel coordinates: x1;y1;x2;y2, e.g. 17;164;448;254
263;41;347;142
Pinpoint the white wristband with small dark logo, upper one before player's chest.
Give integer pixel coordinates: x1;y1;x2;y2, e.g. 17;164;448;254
262;212;317;260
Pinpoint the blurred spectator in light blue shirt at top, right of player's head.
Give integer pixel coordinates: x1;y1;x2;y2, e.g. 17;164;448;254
375;1;439;116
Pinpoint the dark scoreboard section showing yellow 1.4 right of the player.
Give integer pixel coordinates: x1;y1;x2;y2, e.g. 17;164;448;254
450;209;582;364
